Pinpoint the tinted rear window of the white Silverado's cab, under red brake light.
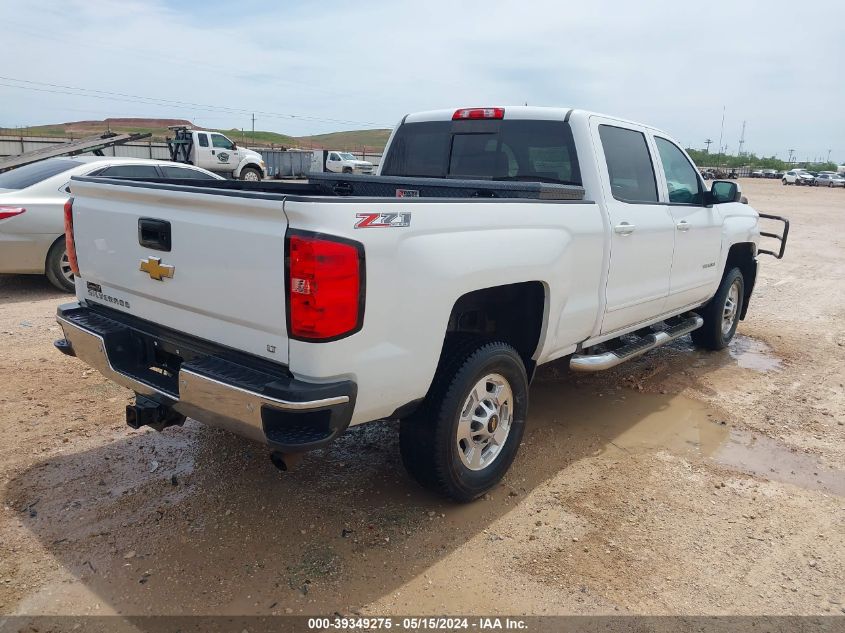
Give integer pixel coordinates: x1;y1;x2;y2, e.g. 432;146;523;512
382;119;581;185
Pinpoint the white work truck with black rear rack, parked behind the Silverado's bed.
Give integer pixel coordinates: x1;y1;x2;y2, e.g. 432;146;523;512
167;125;267;181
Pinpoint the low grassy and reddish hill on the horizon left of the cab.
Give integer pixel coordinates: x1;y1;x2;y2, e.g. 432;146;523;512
0;118;390;152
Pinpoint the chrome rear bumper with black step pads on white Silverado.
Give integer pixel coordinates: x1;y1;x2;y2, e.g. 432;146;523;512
56;304;356;451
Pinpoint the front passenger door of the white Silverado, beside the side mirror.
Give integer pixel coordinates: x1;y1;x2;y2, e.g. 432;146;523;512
654;135;722;311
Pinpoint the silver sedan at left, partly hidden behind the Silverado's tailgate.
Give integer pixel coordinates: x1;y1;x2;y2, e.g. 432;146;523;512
0;156;223;292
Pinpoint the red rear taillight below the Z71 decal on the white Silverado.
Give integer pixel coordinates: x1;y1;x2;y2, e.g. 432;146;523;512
287;233;364;341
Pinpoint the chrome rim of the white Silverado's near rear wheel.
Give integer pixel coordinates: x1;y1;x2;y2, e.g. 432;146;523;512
456;374;514;470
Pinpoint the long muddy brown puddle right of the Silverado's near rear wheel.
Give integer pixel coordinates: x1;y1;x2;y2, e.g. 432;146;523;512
529;381;845;496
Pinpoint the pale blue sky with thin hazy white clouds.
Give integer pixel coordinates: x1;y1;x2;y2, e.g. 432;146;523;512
0;0;845;163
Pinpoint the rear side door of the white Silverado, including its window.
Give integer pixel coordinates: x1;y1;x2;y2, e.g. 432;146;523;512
590;117;675;334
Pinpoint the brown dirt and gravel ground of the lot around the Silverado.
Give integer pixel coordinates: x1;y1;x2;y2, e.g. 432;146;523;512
0;180;845;615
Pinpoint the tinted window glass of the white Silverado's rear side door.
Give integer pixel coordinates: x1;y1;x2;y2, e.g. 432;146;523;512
599;125;657;202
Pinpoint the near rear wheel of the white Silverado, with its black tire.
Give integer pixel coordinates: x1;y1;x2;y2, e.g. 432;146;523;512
399;342;528;502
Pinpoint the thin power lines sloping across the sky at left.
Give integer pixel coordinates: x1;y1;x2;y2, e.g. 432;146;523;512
0;75;390;127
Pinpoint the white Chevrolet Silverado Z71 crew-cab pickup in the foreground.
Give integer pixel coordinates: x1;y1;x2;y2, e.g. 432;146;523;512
56;107;788;501
